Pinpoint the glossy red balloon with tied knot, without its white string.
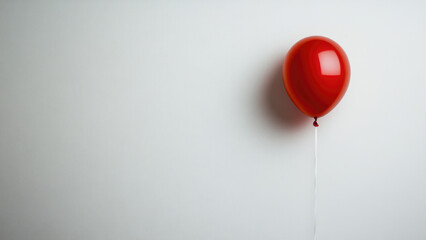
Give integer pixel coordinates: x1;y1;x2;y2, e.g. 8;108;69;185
282;36;350;127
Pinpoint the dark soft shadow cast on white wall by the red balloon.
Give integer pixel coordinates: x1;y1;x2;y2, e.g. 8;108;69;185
263;59;310;131
